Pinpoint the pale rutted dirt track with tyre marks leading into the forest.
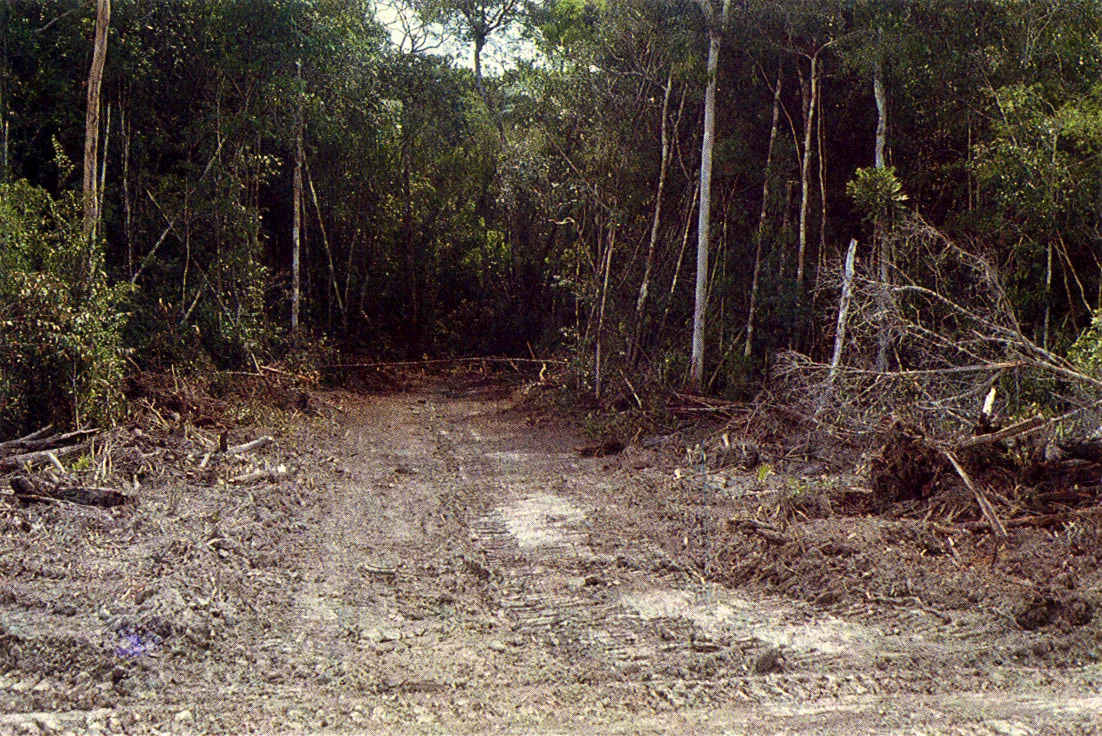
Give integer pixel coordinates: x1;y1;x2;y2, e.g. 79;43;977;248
0;385;1102;734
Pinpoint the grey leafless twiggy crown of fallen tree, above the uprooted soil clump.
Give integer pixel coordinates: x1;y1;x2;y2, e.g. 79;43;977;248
774;209;1102;445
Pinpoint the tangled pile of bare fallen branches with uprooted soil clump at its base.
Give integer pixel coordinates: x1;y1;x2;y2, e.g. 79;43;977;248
776;216;1102;533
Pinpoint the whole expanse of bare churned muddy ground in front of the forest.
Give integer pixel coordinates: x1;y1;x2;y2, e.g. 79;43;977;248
0;378;1102;735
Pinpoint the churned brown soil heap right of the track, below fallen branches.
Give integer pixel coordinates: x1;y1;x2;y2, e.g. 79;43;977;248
643;414;1102;665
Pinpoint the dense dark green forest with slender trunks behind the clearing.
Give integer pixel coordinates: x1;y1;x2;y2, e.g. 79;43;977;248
0;0;1102;436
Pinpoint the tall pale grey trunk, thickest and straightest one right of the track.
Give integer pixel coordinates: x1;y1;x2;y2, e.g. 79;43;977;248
689;0;731;391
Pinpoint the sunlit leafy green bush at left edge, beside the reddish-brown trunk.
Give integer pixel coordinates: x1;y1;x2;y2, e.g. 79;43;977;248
0;181;127;433
